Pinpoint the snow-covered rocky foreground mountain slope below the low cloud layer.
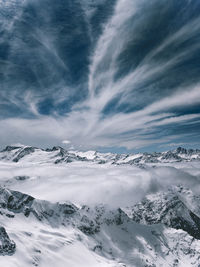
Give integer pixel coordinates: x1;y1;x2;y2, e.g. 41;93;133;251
0;188;200;267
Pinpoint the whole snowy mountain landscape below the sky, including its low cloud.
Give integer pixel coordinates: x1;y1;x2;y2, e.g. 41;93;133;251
0;145;200;267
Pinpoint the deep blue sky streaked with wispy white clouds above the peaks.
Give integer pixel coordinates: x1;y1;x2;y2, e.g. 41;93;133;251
0;0;200;153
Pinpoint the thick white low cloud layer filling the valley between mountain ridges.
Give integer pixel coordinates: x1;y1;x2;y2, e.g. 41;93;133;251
0;162;200;207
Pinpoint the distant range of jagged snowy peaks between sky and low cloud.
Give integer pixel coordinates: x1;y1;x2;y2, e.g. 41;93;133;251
0;146;200;165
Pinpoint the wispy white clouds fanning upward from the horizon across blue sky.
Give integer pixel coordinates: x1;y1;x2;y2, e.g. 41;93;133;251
0;0;200;149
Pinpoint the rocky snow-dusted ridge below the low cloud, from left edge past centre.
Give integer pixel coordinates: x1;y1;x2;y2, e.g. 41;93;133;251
0;188;130;234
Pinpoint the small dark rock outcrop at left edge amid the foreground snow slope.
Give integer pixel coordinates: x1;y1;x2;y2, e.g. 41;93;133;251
0;227;16;256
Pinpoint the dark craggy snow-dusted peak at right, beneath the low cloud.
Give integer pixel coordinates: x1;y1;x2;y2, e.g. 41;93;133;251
126;190;200;239
